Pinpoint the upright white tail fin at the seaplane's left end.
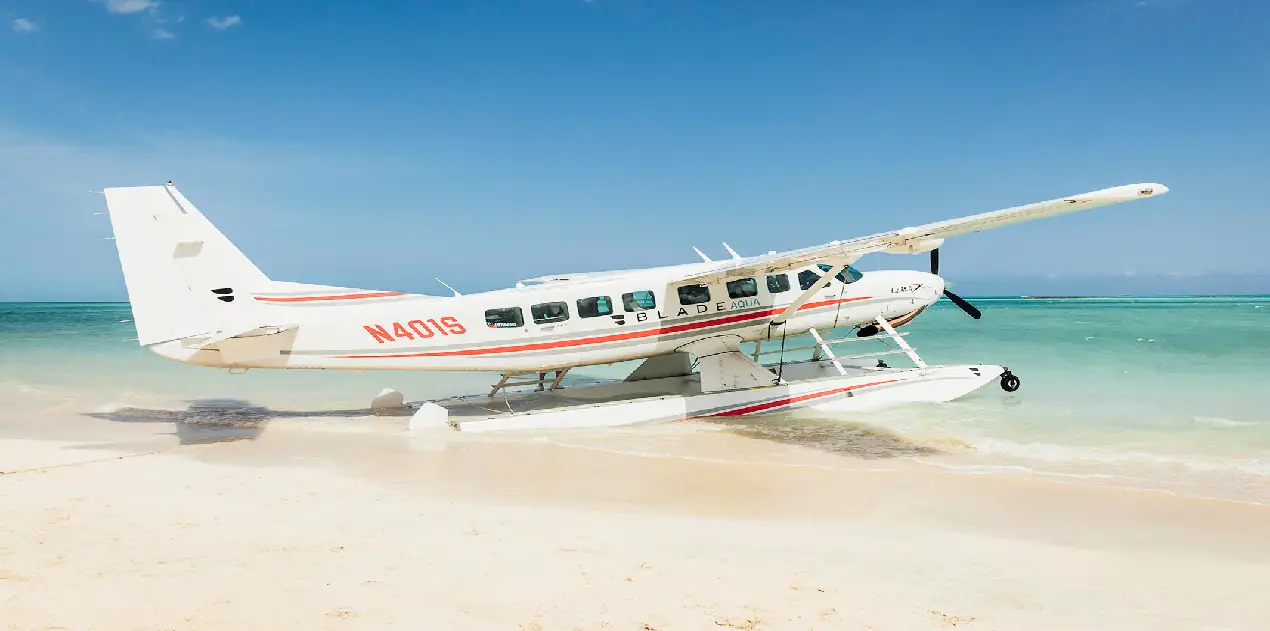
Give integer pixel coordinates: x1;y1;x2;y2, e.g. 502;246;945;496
104;182;269;345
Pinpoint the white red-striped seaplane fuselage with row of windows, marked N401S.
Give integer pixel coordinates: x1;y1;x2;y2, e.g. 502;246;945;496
150;264;944;372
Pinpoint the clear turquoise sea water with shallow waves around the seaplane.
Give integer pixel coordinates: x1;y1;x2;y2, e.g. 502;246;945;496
0;297;1270;503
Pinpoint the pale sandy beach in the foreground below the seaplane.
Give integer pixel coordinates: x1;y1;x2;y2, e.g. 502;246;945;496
0;408;1270;630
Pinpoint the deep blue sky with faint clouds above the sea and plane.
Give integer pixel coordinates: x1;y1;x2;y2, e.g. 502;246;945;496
0;0;1270;300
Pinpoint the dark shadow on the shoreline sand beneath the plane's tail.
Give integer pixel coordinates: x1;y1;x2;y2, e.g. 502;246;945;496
85;399;414;444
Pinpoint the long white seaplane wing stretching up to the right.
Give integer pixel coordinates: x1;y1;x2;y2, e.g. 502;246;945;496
679;179;1168;283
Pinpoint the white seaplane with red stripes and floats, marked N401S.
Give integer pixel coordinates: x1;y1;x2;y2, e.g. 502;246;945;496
103;182;1168;432
